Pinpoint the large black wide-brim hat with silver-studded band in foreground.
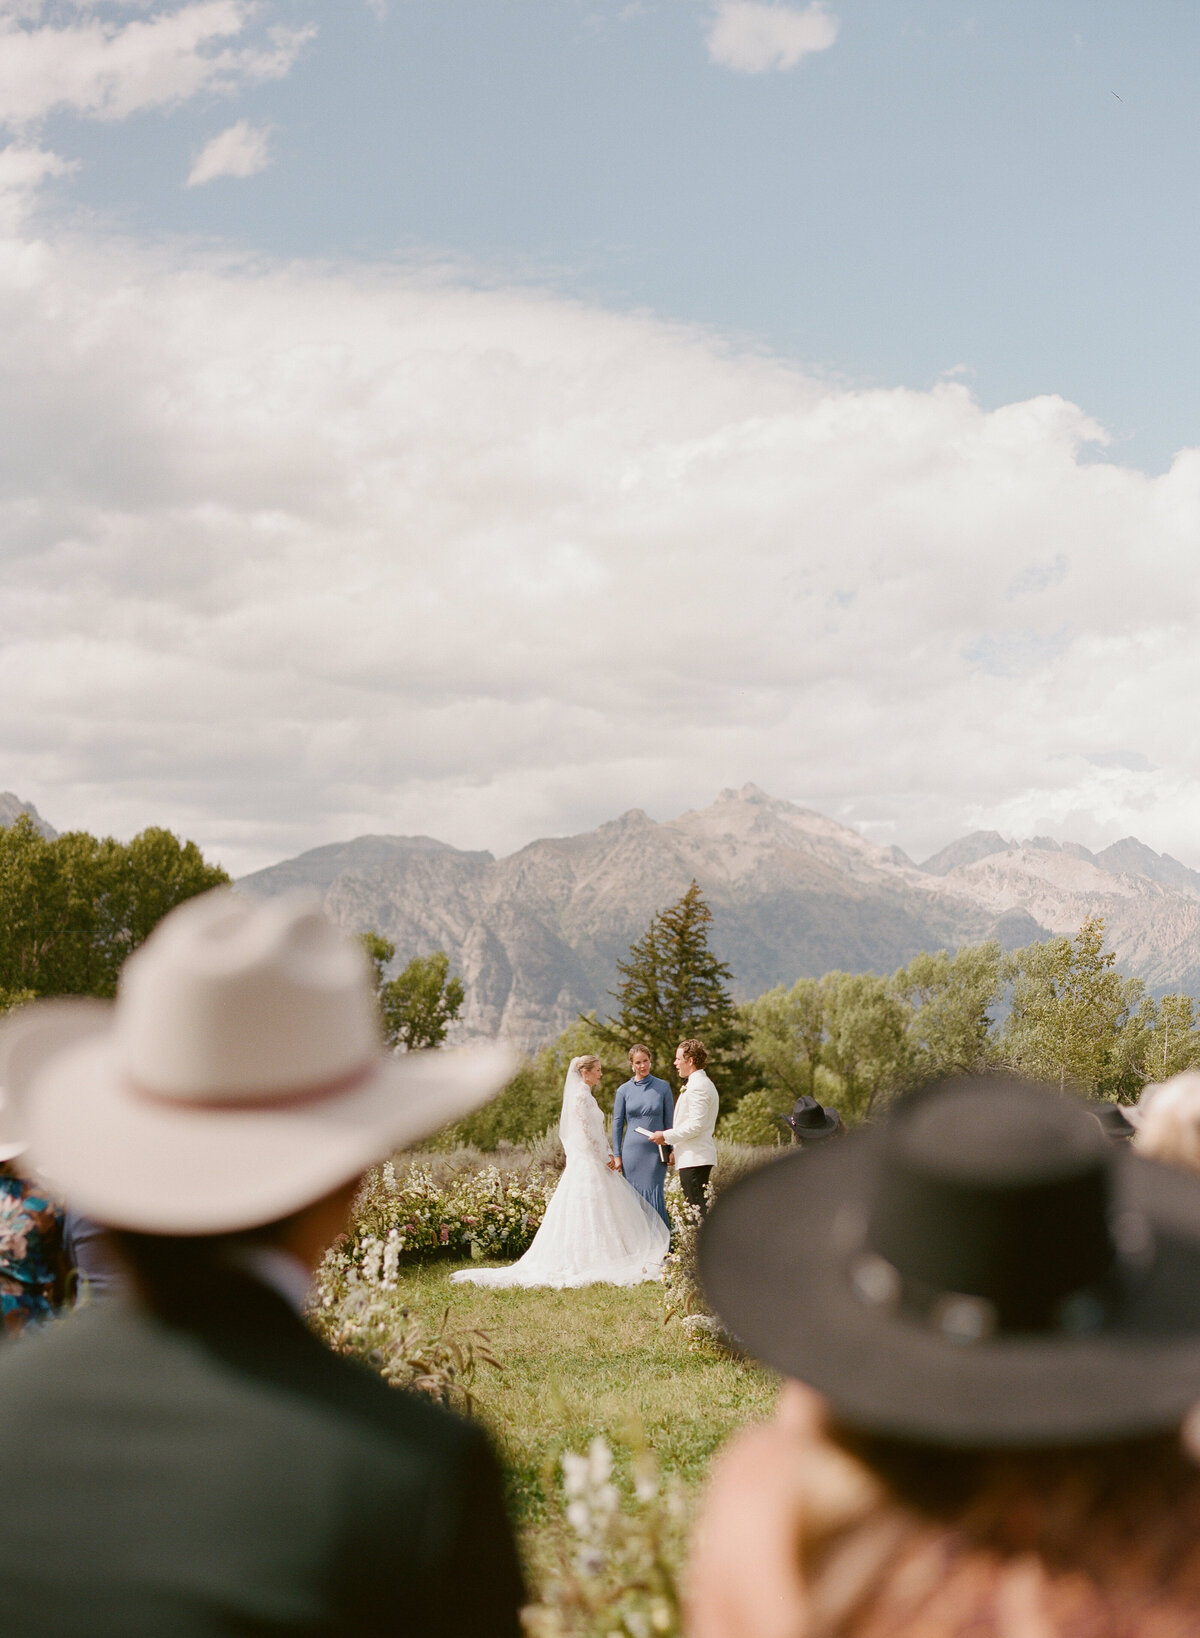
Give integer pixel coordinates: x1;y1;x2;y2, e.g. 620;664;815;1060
699;1079;1200;1450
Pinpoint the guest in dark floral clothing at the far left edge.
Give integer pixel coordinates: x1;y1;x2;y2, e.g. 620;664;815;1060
0;1093;64;1337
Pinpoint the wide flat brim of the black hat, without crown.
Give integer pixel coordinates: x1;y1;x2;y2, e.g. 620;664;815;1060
699;1133;1200;1450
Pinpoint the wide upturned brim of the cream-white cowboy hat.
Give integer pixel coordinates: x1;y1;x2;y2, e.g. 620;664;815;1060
8;1002;516;1235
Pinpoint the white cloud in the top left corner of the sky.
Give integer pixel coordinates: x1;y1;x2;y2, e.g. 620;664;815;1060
0;0;314;131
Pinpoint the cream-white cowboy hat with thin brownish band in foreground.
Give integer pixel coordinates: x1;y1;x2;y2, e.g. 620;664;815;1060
0;888;516;1235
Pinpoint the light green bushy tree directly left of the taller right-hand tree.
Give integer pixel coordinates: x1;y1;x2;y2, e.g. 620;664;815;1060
892;940;1002;1081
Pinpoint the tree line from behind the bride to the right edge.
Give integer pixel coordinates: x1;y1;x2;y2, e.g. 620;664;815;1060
453;881;1200;1148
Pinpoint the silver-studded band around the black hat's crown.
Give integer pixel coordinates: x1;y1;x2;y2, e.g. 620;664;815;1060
850;1251;1120;1345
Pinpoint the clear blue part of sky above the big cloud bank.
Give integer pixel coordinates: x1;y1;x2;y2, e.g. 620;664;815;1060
47;0;1200;470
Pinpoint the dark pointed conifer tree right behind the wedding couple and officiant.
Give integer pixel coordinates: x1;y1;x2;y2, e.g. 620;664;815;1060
601;881;756;1109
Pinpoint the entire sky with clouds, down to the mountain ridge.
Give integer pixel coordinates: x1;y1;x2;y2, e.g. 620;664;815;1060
0;0;1200;871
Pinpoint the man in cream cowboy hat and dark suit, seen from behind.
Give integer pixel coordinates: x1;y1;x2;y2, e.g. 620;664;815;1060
0;891;522;1638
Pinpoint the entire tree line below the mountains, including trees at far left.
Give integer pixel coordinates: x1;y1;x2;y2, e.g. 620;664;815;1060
0;816;1200;1148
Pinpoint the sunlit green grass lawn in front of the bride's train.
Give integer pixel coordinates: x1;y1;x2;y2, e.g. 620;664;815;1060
398;1263;776;1563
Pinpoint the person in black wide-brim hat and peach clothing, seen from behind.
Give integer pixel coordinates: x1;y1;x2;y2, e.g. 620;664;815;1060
688;1079;1200;1638
